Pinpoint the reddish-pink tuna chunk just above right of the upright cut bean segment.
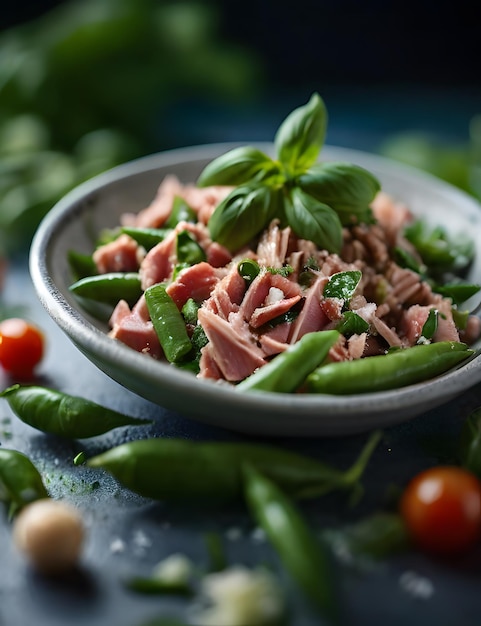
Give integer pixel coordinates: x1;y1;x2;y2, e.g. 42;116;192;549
166;261;219;309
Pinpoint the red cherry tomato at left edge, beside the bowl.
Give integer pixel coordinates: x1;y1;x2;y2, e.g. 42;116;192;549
0;317;45;379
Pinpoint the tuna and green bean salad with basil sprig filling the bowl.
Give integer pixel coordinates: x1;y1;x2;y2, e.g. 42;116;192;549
70;93;481;394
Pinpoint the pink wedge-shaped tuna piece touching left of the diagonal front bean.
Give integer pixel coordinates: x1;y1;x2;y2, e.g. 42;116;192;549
198;307;266;382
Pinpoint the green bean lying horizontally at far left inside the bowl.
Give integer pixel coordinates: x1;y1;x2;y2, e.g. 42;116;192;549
69;272;142;305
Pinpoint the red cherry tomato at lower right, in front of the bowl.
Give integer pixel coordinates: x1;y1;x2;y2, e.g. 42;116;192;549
400;466;481;555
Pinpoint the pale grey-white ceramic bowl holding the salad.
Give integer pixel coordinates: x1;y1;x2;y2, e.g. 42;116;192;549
30;144;481;436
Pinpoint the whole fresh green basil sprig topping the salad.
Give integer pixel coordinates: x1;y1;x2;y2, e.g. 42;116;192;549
197;93;380;252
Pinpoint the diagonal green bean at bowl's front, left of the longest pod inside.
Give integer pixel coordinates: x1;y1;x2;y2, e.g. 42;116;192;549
236;330;340;393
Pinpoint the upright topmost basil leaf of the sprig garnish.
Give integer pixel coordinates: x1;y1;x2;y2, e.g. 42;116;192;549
274;93;327;174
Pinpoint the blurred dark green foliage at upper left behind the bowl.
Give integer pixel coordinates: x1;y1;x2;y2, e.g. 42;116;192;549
0;0;260;253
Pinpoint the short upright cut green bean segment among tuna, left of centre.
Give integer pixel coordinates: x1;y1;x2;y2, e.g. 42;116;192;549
145;283;192;363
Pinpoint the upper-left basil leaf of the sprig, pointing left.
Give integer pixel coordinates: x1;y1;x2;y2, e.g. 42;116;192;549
197;146;279;187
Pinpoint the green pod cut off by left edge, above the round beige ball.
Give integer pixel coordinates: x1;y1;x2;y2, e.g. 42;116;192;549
0;448;48;517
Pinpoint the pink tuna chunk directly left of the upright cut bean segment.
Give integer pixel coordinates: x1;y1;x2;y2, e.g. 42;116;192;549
109;296;163;359
